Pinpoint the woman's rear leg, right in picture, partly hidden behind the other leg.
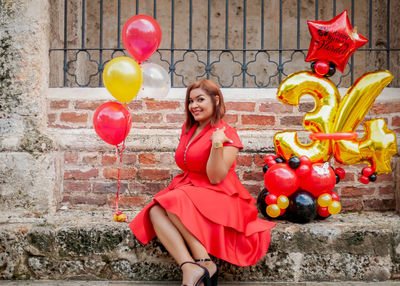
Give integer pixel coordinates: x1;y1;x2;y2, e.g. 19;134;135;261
166;211;217;276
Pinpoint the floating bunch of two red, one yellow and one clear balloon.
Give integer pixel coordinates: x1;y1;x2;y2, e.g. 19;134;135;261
93;15;170;147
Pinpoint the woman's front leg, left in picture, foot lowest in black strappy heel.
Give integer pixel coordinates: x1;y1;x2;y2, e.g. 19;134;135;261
149;205;208;285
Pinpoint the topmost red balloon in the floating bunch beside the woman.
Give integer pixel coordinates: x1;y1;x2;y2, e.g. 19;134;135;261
122;15;161;63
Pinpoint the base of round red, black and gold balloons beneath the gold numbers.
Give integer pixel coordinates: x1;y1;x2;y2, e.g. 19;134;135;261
257;155;345;222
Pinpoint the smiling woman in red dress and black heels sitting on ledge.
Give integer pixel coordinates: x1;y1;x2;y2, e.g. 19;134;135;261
129;80;275;285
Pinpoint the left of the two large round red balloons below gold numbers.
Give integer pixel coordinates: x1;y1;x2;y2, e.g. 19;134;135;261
264;163;299;197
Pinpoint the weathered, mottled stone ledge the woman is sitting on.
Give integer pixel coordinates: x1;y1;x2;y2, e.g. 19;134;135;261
0;211;400;282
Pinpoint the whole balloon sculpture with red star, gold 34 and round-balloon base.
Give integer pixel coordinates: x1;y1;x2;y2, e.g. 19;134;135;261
257;11;397;222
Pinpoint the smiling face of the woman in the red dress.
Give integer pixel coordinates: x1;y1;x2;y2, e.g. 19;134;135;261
188;88;219;124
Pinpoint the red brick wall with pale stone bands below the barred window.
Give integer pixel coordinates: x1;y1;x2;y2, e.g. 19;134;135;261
47;88;400;211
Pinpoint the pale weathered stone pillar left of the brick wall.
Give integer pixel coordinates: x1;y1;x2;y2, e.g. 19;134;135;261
0;0;58;213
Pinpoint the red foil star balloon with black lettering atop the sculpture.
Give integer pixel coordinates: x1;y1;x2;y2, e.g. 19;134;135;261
306;10;368;72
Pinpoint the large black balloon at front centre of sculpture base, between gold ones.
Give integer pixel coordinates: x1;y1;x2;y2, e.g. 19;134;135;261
286;190;317;223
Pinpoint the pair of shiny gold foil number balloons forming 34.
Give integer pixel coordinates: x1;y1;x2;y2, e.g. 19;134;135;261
274;71;397;174
